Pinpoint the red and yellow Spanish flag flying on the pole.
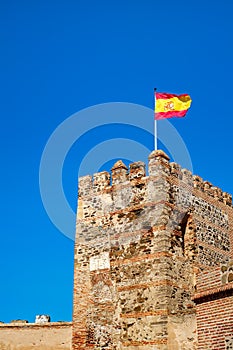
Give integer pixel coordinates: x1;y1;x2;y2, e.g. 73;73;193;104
155;92;192;120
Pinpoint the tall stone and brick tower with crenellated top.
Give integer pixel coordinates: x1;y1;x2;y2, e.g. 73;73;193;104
72;151;233;350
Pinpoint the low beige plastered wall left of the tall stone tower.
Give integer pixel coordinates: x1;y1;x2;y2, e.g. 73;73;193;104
0;322;72;350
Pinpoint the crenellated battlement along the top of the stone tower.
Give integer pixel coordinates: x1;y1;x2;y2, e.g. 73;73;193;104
79;150;232;206
